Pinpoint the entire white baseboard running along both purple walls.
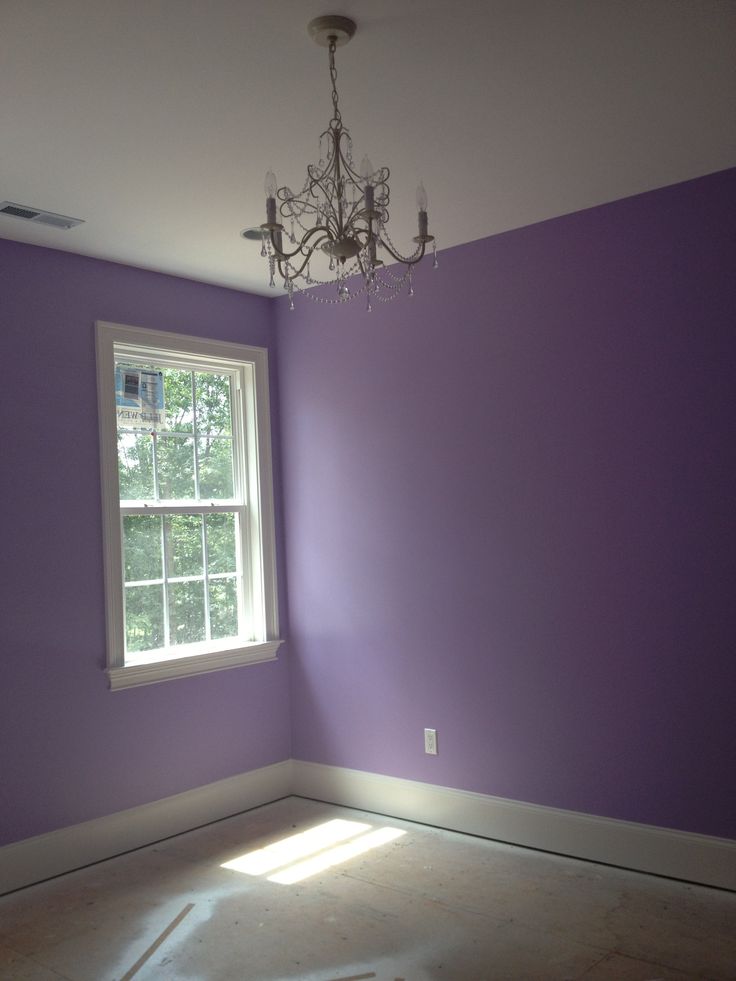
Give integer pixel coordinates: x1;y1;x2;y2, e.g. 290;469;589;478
0;760;736;895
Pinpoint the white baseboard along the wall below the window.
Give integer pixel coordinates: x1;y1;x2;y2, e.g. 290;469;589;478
0;760;292;895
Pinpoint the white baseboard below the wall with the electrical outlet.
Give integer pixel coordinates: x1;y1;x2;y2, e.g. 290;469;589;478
292;760;736;890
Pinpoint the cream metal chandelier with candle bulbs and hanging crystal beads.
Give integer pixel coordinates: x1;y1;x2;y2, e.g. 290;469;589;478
260;16;437;311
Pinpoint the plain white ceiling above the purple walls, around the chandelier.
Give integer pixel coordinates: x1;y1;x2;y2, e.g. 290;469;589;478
0;0;736;293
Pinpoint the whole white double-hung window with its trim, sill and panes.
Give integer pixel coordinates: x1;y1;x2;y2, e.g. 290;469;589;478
97;323;280;688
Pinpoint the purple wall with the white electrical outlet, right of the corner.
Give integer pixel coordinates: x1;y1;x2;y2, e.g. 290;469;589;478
276;170;736;836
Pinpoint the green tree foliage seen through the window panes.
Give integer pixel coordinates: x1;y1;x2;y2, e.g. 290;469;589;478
118;365;238;652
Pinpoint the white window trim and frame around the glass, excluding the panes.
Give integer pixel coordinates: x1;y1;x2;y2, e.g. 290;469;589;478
95;321;282;690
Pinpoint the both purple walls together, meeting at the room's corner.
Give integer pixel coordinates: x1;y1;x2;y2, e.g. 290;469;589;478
0;170;736;844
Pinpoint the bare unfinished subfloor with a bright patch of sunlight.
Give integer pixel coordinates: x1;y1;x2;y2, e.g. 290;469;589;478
0;797;736;981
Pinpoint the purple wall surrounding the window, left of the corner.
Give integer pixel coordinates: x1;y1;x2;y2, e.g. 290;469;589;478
0;241;290;844
